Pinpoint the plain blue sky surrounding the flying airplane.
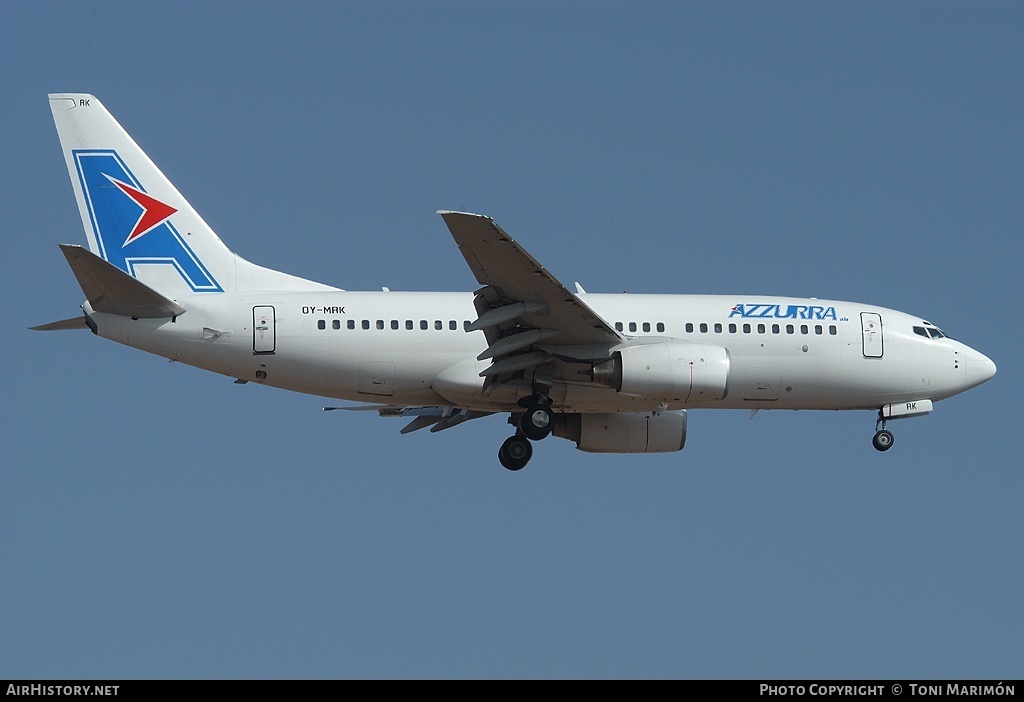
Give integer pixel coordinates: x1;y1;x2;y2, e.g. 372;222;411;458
0;2;1024;679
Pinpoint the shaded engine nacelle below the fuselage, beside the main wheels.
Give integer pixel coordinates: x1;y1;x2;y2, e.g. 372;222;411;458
554;409;686;453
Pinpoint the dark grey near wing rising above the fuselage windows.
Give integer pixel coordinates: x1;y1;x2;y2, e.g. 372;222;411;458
438;211;626;376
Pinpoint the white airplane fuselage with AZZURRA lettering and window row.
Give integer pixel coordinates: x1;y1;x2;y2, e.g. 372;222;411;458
87;291;994;412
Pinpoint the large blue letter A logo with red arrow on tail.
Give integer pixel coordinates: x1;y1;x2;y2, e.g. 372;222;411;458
72;149;223;293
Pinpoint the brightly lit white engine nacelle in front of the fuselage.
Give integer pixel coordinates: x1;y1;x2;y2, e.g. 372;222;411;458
594;341;730;402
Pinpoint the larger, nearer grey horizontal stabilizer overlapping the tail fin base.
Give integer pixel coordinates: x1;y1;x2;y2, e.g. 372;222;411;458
60;244;185;318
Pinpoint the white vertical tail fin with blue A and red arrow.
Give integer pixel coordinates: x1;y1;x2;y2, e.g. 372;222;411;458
49;93;332;297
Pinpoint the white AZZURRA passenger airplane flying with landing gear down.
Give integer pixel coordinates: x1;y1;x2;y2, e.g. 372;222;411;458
32;93;995;471
